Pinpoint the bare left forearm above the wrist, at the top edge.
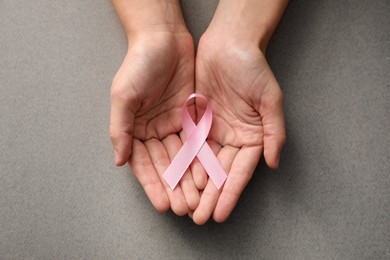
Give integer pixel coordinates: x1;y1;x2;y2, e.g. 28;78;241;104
112;0;187;36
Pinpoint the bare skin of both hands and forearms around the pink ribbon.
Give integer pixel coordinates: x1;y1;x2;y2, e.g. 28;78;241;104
110;0;287;224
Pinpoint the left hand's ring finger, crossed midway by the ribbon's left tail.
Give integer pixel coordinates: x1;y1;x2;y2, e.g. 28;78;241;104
163;135;200;210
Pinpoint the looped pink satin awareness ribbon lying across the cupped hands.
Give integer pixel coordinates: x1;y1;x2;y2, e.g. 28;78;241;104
164;93;227;190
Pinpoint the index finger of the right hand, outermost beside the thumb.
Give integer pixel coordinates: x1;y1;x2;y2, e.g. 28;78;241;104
213;146;262;222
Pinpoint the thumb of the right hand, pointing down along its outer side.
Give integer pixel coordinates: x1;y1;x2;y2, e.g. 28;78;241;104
259;79;286;168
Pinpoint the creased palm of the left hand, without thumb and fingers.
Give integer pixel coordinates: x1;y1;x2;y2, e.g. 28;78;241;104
115;34;194;141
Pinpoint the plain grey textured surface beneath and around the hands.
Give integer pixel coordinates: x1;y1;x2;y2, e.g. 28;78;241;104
0;0;390;259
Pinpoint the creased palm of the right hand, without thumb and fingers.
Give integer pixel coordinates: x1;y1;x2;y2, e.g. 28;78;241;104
196;45;268;148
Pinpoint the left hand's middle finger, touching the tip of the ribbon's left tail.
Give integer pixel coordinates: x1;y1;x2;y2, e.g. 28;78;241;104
145;139;188;216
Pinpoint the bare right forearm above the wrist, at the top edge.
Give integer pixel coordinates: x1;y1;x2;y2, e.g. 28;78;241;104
208;0;288;51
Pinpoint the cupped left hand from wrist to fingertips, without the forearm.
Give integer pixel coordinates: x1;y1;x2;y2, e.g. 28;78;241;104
110;32;199;215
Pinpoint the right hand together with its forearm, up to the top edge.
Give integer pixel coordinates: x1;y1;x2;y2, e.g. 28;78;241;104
190;0;287;224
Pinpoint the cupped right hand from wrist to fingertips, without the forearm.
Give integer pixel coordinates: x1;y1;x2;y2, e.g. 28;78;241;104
190;33;286;224
